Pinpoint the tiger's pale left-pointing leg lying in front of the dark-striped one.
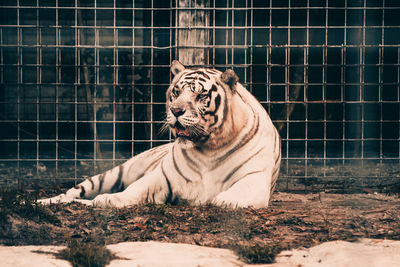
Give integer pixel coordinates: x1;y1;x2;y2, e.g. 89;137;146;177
78;163;172;208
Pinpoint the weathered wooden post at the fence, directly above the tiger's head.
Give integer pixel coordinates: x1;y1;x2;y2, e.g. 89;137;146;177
176;0;210;65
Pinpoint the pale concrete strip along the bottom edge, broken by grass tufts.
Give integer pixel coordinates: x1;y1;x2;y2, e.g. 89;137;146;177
0;239;400;267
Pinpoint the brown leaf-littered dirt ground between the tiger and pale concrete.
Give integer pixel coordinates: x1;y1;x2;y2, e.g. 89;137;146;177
0;192;400;262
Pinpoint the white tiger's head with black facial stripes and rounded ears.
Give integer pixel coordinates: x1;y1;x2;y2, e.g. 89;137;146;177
166;60;238;149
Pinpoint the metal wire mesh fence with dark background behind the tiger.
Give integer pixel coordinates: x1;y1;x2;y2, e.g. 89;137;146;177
0;0;400;193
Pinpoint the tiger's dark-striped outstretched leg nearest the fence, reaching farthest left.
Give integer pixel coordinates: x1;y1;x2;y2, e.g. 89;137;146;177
38;144;172;204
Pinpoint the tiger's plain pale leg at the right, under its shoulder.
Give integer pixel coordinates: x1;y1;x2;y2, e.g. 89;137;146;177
212;170;279;208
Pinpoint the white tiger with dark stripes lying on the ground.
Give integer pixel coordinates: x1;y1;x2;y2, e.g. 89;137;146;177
39;60;281;208
